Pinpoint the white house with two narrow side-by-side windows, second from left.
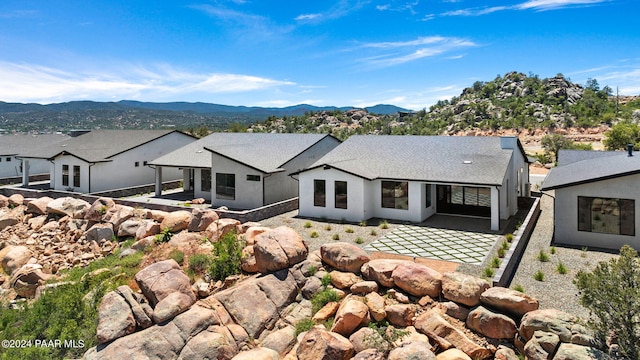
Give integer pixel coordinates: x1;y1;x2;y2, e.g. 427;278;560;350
19;130;195;193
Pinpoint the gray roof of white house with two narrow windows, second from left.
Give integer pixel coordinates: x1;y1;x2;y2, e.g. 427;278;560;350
20;130;190;162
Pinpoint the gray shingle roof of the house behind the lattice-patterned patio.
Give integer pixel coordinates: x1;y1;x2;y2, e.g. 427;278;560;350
302;135;513;185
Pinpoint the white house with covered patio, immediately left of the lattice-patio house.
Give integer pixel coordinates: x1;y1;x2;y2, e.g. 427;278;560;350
150;133;340;209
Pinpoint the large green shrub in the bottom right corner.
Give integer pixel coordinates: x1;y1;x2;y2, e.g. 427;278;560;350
573;245;640;359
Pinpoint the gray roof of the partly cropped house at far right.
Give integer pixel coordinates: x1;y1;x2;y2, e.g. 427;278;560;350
541;151;640;190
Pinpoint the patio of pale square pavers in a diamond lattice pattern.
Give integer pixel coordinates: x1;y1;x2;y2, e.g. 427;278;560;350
364;225;500;264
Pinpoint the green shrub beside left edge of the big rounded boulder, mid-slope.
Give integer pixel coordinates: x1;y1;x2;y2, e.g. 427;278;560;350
209;232;244;280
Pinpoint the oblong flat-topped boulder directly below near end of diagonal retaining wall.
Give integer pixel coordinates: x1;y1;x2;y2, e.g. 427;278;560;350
480;286;540;317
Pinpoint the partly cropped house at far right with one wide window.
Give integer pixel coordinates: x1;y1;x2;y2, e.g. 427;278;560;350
542;150;640;250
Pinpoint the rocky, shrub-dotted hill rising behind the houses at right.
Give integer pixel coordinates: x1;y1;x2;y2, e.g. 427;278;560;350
250;72;640;138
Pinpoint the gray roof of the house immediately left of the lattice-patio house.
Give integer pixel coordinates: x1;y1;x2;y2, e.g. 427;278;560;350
149;133;331;173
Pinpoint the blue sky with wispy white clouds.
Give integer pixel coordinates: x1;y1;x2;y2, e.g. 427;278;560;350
0;0;640;110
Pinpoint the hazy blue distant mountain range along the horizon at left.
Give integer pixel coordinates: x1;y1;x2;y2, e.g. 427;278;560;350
0;100;407;132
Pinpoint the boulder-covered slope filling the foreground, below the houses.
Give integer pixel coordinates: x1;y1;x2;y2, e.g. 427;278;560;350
0;195;620;360
